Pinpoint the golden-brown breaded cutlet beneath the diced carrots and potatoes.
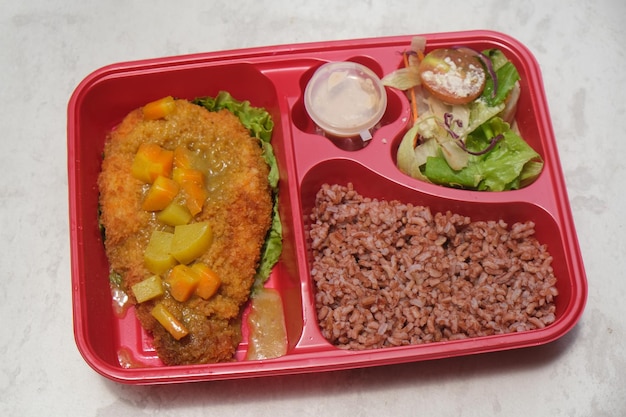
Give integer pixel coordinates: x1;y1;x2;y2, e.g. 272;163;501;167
98;100;272;365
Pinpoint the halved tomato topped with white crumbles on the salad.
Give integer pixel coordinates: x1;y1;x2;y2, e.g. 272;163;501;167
418;49;486;104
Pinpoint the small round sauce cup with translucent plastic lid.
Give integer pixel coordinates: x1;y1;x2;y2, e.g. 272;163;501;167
304;61;387;140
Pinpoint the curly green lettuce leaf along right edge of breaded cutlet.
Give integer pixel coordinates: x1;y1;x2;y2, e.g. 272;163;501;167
192;91;283;288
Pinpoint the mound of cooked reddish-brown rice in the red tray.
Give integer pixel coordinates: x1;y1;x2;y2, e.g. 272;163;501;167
310;184;558;350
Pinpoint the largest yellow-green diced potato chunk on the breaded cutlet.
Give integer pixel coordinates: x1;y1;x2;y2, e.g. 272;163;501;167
170;222;213;265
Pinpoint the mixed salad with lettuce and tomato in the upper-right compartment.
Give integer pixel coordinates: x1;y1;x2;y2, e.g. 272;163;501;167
383;37;543;191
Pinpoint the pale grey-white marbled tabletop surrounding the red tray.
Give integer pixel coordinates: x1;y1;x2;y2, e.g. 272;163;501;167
0;0;626;417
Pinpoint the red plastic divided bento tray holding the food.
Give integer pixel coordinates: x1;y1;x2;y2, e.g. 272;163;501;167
68;31;587;384
